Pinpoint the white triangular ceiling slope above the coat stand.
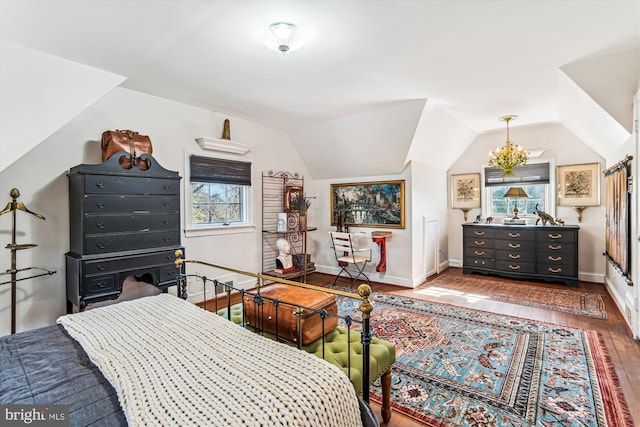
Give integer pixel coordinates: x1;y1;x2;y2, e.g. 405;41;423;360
0;42;125;171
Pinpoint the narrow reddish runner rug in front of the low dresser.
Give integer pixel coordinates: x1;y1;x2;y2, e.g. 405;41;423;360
421;274;607;319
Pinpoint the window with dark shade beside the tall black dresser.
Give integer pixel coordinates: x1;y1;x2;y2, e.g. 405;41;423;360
185;154;251;234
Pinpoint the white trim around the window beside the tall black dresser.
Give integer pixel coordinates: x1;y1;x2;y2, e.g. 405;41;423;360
183;150;256;238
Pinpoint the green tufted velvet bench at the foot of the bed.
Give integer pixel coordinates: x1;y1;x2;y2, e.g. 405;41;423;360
217;304;396;423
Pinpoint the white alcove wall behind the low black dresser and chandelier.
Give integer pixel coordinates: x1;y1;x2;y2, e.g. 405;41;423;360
448;124;605;283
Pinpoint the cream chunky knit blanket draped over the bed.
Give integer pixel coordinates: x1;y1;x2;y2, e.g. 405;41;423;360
58;294;361;427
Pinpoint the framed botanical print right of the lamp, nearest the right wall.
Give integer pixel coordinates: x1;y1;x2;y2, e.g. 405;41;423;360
556;163;600;206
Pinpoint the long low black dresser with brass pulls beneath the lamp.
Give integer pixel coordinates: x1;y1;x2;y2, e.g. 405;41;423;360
462;223;579;286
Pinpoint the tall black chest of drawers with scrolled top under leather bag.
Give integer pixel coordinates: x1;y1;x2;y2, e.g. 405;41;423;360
66;152;186;312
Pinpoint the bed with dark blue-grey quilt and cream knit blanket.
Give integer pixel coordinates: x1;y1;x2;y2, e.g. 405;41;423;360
0;256;378;426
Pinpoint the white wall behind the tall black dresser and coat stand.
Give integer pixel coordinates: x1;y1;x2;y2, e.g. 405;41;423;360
0;88;308;335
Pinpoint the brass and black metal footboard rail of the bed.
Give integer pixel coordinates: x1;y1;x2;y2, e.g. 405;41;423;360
175;249;373;403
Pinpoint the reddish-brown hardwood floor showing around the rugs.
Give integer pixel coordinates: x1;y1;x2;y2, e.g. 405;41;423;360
307;268;640;427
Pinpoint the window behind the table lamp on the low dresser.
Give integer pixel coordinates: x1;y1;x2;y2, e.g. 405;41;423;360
484;162;555;217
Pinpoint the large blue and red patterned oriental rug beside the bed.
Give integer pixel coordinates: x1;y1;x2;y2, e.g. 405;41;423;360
338;293;633;427
